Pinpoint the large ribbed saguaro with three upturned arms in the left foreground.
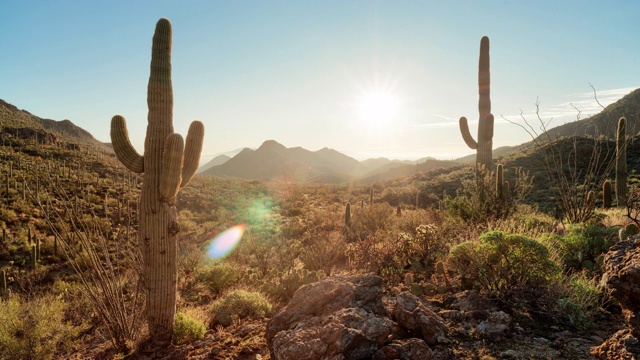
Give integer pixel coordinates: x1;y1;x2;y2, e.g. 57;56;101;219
111;18;204;343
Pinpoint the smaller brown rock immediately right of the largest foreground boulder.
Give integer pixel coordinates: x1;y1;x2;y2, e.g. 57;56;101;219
393;292;447;345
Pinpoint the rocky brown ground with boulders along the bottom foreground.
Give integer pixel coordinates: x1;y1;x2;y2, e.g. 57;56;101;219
72;236;640;360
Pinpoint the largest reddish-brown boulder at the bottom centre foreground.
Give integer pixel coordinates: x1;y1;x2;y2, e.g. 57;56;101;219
265;275;395;360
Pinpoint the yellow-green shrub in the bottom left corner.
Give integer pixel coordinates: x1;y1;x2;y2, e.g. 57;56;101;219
0;295;82;359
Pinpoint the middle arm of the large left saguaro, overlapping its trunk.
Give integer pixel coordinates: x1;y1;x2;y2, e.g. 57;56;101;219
160;133;184;204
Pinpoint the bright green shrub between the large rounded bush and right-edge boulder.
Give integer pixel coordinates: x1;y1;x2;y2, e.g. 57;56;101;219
540;224;618;270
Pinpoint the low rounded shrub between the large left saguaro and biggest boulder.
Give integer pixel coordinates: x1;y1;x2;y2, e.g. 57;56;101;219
211;290;273;326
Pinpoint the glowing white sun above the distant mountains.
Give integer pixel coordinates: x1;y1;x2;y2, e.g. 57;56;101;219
358;89;398;125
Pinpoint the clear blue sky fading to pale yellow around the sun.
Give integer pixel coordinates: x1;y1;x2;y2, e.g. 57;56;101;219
0;0;640;164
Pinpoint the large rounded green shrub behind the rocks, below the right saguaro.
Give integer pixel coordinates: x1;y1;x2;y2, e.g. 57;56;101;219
449;231;556;299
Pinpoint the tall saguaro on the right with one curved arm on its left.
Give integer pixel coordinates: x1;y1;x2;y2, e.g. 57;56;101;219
460;36;493;171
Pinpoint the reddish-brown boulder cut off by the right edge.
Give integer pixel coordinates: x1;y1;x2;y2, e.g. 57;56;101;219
602;235;640;337
